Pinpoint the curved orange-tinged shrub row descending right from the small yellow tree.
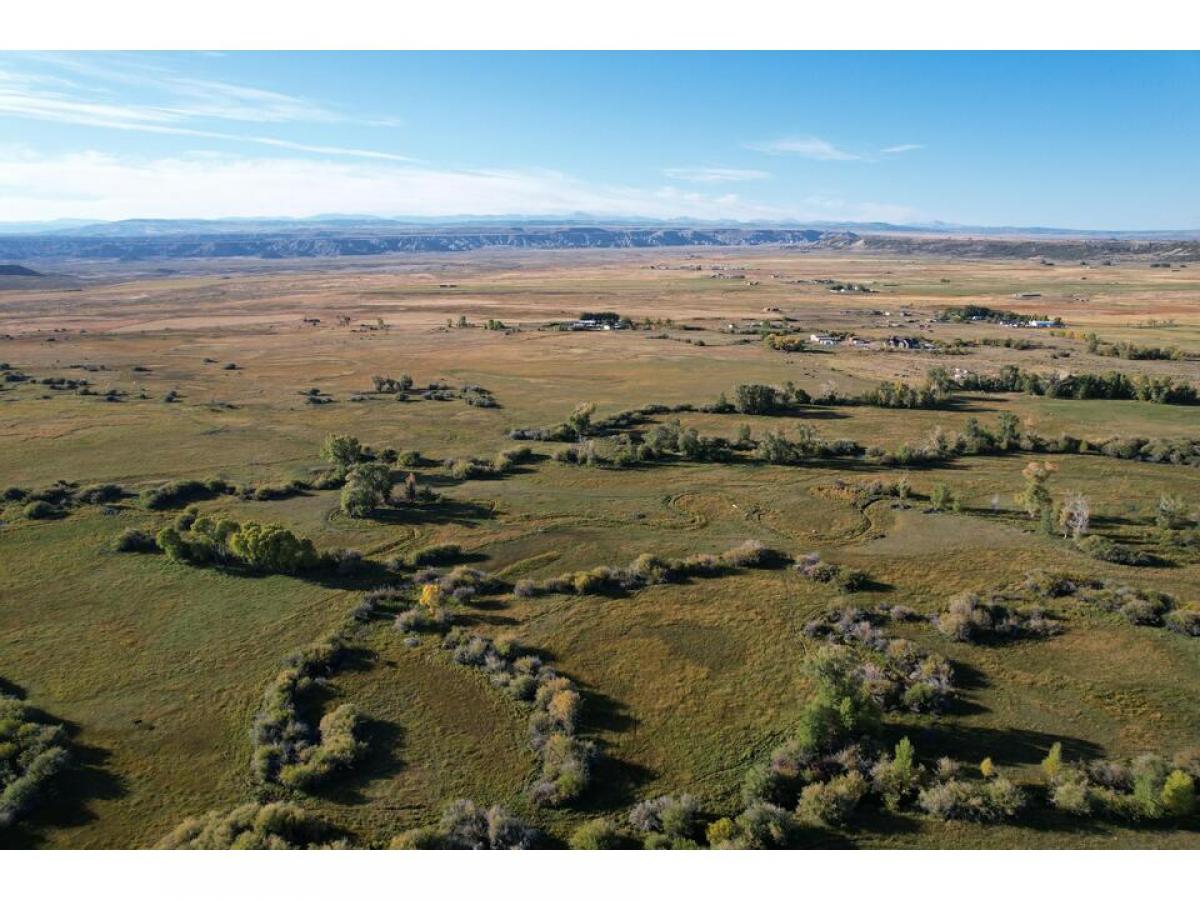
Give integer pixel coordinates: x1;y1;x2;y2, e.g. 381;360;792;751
442;629;599;806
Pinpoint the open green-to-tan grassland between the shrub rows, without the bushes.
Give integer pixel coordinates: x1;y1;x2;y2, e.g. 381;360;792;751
0;250;1200;847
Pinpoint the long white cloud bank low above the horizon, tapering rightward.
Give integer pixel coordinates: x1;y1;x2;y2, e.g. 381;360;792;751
0;148;917;221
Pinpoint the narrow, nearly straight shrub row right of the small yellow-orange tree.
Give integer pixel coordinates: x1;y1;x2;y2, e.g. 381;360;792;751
512;541;790;596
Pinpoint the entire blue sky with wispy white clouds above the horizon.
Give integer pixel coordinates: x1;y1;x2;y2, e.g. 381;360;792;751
0;53;1200;229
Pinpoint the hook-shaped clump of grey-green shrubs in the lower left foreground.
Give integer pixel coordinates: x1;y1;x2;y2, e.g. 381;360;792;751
251;635;366;791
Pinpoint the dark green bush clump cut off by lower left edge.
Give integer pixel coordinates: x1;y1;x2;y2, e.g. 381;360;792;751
0;691;71;829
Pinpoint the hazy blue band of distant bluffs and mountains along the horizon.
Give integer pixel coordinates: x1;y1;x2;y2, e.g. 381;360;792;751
0;216;1200;263
